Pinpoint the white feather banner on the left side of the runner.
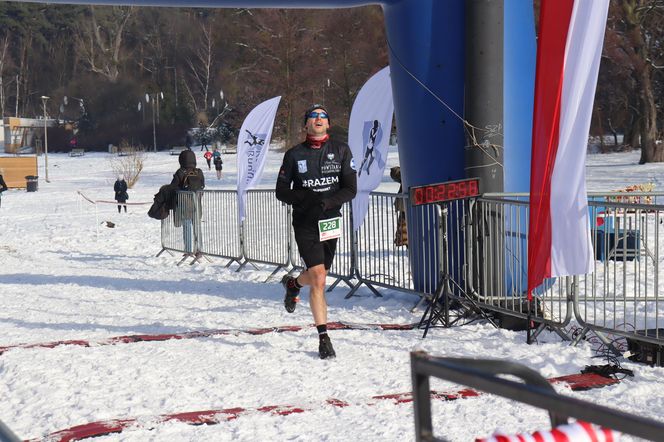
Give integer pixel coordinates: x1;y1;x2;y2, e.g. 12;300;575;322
237;96;281;221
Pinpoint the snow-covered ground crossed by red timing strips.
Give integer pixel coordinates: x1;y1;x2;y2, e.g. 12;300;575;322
0;149;664;441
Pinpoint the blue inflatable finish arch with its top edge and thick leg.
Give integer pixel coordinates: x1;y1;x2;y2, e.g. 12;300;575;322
24;0;535;294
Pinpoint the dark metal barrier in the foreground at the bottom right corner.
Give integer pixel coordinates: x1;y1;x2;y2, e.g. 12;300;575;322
410;352;664;442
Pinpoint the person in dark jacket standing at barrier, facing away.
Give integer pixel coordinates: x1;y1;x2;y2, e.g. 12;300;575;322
171;150;205;255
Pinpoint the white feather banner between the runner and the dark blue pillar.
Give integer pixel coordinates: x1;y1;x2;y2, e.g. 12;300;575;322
348;66;394;230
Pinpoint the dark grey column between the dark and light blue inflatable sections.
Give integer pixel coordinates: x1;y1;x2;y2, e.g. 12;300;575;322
464;0;505;296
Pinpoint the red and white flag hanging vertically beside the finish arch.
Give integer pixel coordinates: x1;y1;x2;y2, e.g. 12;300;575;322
528;0;609;298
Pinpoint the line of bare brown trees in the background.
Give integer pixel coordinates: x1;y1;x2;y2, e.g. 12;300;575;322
0;0;664;162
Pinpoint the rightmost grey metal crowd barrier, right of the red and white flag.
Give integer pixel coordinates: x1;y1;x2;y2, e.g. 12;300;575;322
574;194;664;344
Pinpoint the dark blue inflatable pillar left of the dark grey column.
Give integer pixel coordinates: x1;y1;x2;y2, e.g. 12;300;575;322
383;0;464;292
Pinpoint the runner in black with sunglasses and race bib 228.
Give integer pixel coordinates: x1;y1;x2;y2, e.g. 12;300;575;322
276;104;357;359
